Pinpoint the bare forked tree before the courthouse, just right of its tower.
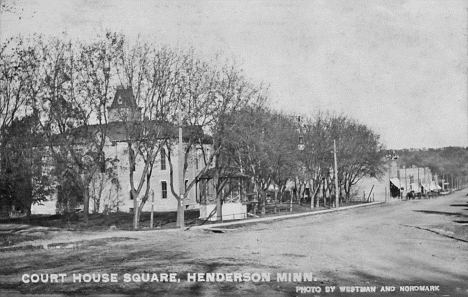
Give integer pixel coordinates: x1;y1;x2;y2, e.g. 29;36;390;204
114;37;188;229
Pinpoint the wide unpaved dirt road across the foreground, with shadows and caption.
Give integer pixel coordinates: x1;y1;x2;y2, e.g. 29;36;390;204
0;192;468;296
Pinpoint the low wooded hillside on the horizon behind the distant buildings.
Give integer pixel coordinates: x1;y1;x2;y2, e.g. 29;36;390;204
395;146;468;178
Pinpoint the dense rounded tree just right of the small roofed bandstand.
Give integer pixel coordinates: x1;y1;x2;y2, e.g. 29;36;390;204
224;106;298;213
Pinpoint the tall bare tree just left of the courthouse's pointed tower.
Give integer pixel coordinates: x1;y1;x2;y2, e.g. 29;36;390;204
36;36;119;222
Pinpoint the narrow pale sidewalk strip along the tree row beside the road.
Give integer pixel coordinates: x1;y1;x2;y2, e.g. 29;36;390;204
188;201;385;230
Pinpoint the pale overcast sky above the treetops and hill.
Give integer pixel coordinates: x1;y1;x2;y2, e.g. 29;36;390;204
0;0;468;149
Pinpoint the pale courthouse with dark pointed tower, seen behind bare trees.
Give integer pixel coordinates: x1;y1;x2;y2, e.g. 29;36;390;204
32;88;210;213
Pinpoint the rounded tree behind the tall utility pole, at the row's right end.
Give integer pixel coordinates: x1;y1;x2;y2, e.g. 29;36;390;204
300;113;383;205
